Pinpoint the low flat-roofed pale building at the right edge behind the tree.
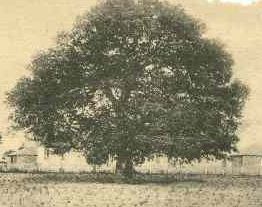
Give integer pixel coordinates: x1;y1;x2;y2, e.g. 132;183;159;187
231;154;262;175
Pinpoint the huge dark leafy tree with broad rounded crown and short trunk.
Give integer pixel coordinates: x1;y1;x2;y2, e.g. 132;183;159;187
8;0;247;175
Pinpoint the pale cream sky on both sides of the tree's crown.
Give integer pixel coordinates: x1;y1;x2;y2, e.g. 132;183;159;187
0;0;262;152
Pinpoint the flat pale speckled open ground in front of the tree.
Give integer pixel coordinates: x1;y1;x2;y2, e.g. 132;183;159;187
0;173;262;207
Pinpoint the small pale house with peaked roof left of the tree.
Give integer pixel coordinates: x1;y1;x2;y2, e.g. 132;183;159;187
2;144;38;171
